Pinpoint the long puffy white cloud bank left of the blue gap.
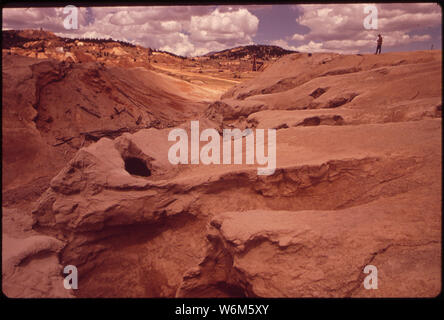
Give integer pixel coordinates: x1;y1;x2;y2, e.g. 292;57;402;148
3;6;259;56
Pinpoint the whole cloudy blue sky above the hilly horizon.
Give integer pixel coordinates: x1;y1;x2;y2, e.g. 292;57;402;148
3;3;442;56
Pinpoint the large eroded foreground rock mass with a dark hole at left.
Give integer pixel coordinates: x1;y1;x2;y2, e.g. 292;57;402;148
29;115;441;297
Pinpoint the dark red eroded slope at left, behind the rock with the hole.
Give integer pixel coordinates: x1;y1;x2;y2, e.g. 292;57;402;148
2;56;212;204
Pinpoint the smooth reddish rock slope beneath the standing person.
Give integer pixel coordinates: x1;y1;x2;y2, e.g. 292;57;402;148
212;51;442;127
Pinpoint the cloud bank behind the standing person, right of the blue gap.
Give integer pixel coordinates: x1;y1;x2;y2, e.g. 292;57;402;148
292;3;442;53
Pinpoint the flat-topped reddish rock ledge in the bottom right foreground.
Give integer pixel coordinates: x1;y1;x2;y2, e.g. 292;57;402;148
178;189;441;298
